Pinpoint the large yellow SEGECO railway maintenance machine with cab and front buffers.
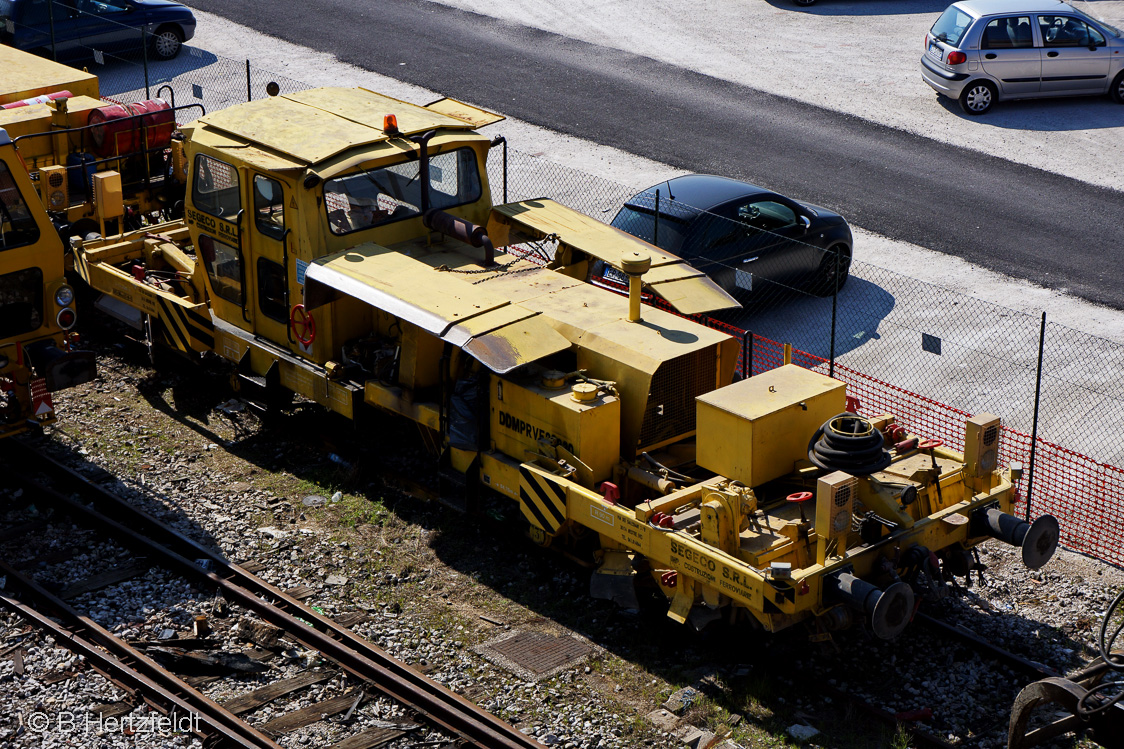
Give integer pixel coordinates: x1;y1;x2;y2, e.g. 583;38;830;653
52;78;1058;637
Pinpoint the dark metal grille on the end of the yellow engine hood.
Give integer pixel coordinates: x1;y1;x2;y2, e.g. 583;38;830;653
640;346;718;450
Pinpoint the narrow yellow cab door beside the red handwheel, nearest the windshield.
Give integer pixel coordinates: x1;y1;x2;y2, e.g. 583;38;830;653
246;172;293;349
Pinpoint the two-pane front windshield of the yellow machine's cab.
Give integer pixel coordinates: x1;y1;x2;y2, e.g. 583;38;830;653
324;148;481;235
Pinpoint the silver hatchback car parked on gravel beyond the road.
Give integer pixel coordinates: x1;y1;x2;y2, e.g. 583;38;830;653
921;0;1124;115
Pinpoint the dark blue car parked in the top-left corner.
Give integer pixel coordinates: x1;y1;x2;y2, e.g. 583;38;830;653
0;0;196;61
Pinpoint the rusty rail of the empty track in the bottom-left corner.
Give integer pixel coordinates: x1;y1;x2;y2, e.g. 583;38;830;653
0;561;274;749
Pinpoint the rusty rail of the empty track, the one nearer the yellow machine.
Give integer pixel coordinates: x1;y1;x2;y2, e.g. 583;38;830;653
8;441;542;749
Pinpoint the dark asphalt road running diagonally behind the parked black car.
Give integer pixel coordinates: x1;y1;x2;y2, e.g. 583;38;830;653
177;0;1124;309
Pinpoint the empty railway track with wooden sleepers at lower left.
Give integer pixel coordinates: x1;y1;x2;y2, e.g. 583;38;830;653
0;441;541;749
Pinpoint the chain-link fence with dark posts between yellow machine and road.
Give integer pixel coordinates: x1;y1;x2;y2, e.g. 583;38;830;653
10;32;1124;565
